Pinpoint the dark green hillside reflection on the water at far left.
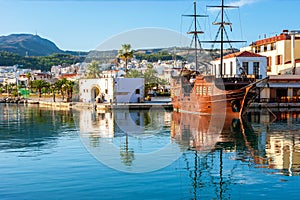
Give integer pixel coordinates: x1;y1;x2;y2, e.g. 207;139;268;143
0;104;73;152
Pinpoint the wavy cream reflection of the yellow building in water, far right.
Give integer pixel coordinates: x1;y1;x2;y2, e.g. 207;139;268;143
249;110;300;175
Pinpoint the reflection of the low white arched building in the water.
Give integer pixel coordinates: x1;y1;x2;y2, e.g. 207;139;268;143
79;110;171;138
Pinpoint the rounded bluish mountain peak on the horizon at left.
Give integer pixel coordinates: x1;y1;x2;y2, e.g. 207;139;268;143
0;34;64;56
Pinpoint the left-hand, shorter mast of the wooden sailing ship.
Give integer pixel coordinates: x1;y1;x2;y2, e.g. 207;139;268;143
182;0;208;71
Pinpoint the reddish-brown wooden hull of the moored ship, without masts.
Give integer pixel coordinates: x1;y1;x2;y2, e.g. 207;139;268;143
172;75;263;116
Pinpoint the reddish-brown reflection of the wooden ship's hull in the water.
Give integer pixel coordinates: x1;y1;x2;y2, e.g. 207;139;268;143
171;112;247;153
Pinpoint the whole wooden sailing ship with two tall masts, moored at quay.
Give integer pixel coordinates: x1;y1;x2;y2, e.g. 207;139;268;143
171;0;268;117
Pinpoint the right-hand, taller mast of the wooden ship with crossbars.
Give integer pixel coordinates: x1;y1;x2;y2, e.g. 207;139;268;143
203;0;246;77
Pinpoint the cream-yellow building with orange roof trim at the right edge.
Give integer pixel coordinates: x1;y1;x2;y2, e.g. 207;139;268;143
241;30;300;104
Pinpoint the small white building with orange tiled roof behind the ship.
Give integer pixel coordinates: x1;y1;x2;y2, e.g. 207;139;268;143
211;51;267;78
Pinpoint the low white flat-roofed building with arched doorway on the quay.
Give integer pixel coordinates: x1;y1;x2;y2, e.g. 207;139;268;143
79;78;144;103
